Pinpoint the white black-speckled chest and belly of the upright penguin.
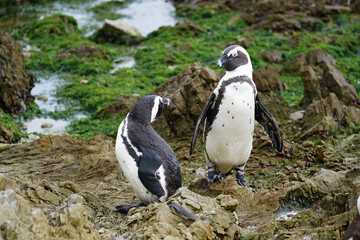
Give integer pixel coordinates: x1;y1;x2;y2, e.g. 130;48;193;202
205;82;255;173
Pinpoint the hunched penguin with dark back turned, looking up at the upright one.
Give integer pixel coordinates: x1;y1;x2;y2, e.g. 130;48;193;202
115;95;181;214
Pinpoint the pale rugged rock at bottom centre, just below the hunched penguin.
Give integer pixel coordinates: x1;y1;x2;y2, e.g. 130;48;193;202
122;188;242;239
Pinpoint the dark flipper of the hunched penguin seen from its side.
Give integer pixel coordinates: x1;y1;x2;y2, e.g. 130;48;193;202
138;145;165;197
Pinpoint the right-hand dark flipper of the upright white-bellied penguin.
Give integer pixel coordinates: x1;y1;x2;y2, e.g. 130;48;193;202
255;95;283;152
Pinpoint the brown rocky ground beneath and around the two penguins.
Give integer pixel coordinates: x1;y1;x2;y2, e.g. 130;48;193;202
0;1;360;240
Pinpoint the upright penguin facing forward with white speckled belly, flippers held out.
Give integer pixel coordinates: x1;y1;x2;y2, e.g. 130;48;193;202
190;45;283;192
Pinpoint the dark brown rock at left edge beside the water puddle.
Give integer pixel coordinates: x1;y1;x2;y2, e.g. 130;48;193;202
0;30;36;113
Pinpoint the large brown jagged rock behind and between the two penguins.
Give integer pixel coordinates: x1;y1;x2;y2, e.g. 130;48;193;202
151;63;220;137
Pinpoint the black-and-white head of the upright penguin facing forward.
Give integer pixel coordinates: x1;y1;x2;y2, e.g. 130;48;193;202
216;45;252;71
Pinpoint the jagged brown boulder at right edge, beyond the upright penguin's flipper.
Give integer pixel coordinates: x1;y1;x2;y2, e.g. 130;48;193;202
284;49;360;138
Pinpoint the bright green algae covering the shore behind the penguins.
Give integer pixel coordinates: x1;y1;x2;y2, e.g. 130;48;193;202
6;7;360;140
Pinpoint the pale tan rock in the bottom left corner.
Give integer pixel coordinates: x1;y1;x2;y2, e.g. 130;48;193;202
0;189;50;239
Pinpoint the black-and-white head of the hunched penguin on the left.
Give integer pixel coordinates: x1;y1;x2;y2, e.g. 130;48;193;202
129;95;171;122
